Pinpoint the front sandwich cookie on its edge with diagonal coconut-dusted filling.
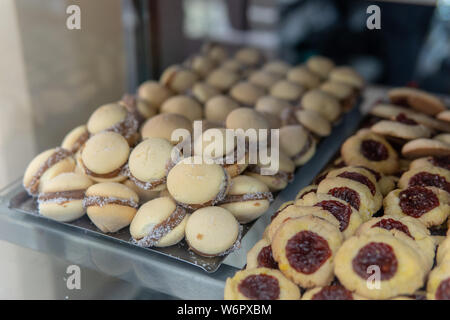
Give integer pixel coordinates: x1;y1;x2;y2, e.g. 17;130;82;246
130;197;189;247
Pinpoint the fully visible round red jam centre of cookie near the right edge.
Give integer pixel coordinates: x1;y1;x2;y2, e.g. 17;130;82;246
399;186;439;218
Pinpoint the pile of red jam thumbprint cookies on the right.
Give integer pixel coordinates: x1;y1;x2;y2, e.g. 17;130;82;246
224;88;450;300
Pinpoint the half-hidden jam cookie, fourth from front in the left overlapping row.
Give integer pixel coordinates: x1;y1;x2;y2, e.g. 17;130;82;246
317;177;380;221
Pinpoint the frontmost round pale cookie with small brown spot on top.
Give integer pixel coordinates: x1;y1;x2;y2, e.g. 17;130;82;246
185;207;240;257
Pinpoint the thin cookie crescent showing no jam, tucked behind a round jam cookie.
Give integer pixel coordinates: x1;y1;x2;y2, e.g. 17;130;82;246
266;205;339;241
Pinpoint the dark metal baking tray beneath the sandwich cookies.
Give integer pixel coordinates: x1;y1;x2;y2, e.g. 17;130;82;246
4;105;362;273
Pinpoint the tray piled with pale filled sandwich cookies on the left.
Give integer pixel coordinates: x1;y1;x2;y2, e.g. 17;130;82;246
7;44;364;272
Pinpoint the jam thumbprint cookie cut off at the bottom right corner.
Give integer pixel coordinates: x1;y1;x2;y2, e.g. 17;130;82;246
427;261;450;300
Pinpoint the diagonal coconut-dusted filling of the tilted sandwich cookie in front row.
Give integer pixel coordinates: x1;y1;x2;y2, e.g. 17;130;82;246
132;206;186;247
